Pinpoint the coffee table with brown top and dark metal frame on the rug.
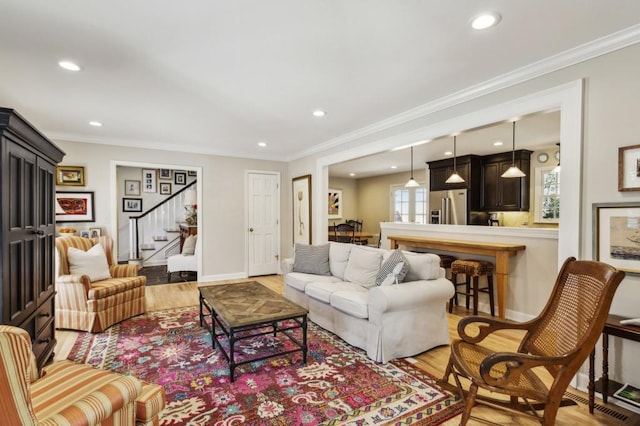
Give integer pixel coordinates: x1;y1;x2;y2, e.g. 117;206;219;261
199;281;309;382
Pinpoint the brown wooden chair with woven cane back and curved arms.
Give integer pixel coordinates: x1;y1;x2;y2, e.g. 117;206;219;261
444;257;625;425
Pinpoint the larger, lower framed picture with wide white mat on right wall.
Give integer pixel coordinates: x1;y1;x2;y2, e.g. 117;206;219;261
593;202;640;274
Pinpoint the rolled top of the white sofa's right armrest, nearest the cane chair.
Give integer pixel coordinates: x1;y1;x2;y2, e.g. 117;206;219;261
367;278;454;312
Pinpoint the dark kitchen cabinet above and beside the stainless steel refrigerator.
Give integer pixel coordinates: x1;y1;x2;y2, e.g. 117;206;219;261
427;155;482;210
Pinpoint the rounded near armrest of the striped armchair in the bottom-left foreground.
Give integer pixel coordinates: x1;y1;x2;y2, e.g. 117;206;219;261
38;376;142;426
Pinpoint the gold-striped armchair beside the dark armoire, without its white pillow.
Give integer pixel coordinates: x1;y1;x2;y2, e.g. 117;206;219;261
55;236;147;333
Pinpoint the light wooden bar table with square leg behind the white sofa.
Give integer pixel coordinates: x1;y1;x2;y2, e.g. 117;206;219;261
387;235;526;319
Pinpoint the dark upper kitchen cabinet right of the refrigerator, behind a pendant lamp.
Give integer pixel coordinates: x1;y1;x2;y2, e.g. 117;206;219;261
480;149;532;211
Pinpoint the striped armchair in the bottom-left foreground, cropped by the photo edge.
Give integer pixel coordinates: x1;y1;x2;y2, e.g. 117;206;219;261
0;325;166;426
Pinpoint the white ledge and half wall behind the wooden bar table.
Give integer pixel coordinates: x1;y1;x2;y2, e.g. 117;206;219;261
380;222;560;321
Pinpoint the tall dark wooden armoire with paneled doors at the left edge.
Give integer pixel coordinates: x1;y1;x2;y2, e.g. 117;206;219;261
0;108;64;367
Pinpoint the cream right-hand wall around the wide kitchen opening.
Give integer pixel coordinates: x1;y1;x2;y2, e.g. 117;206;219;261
290;45;640;385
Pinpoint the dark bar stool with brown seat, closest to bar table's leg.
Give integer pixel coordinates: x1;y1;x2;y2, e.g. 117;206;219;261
449;259;495;316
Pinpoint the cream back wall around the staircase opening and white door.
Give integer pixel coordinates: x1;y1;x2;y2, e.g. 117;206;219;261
55;141;284;281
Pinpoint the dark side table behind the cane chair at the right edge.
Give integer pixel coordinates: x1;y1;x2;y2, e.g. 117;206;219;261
589;315;640;414
